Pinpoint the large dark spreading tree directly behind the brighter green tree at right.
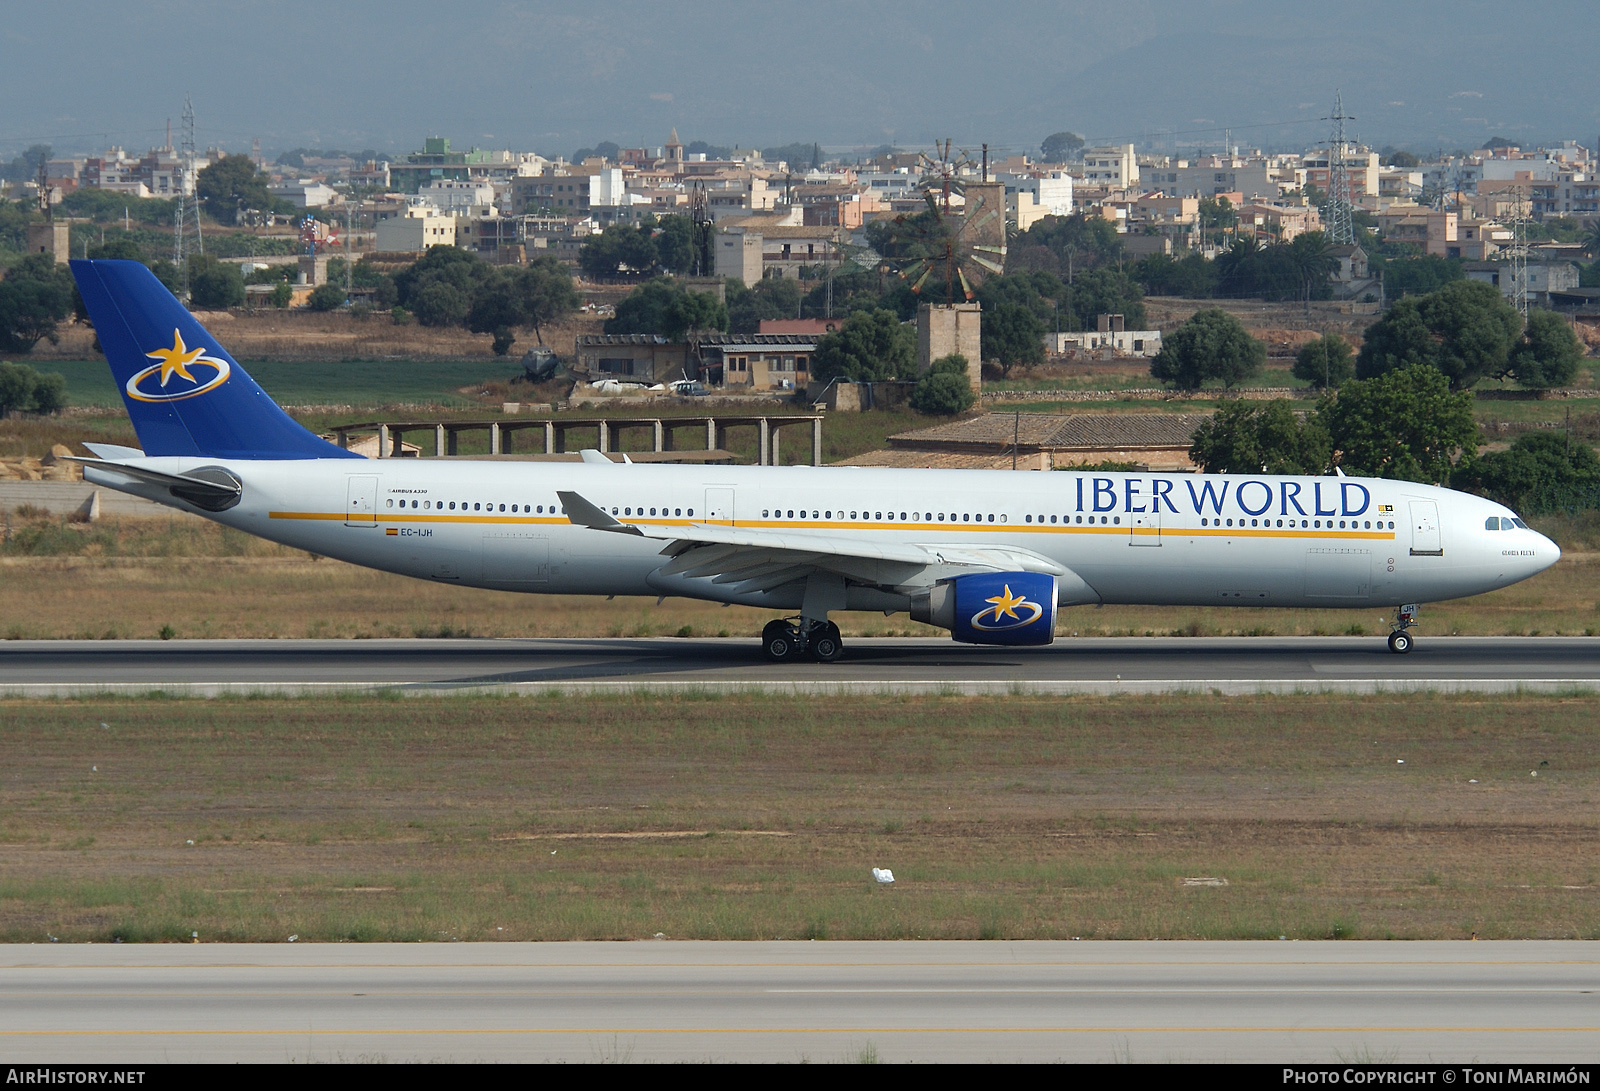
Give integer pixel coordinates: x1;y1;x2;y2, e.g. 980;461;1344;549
1355;280;1522;390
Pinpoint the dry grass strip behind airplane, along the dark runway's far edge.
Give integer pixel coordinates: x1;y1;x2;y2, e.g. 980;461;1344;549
0;514;1600;640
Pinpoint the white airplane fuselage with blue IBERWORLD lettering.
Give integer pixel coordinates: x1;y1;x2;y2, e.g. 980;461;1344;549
86;458;1560;609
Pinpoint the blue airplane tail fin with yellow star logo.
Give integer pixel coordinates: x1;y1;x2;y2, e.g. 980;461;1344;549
72;261;360;459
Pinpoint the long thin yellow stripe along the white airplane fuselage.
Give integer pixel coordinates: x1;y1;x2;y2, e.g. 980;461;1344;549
267;512;1398;541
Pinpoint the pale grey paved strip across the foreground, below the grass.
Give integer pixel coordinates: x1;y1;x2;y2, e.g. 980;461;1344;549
0;942;1600;1064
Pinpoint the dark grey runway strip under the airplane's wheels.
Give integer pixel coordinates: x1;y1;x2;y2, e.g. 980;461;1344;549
0;637;1600;697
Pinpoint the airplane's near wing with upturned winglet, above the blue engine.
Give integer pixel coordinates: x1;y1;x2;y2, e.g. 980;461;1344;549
557;493;1077;595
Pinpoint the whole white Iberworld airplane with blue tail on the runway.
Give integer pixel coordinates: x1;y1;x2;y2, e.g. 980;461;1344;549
72;261;1560;662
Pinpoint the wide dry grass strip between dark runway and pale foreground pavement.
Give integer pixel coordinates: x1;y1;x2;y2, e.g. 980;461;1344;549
0;697;1600;941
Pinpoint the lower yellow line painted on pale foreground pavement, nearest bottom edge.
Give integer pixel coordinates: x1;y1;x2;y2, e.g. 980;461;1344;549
0;1025;1600;1038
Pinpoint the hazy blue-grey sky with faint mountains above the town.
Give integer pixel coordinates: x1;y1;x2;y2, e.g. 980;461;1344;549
0;0;1600;157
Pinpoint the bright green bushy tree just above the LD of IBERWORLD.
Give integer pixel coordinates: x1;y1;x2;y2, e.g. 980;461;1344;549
1317;363;1478;485
